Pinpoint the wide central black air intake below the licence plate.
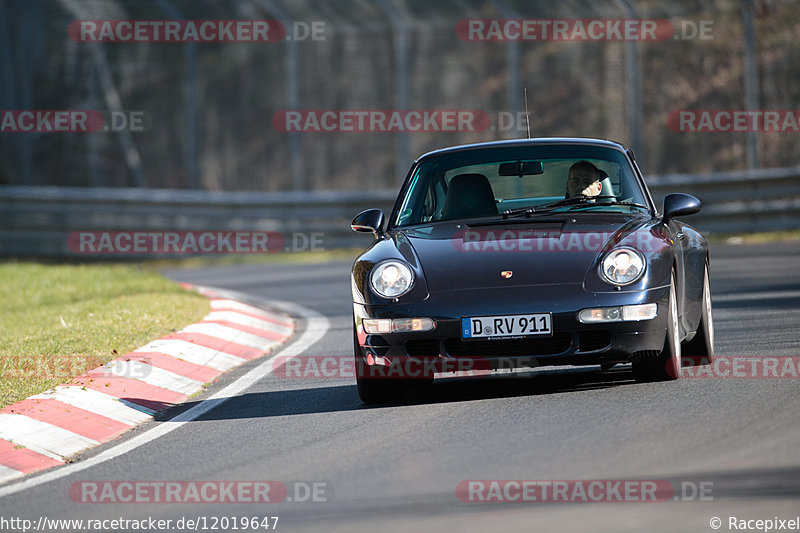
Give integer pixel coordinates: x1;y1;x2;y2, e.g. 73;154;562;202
444;333;572;357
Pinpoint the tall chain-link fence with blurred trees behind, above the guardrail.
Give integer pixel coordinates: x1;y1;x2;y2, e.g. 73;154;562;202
0;0;800;191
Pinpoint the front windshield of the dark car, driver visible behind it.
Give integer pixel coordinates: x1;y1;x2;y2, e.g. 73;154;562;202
394;145;647;226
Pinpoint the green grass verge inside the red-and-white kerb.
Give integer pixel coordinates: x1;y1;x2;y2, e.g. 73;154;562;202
0;262;209;406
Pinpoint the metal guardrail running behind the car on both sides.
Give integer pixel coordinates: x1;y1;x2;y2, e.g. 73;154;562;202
0;167;800;257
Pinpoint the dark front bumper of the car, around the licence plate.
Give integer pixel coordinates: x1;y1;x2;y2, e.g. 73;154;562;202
354;284;669;373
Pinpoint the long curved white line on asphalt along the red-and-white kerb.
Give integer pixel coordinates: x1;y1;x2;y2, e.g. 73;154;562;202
0;302;330;498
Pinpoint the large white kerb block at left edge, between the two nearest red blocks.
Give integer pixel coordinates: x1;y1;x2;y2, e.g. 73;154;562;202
0;413;100;461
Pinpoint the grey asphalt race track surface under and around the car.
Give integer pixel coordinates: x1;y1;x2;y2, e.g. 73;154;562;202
0;242;800;532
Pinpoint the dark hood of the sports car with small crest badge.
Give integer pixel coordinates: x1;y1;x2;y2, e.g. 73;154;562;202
394;214;654;293
